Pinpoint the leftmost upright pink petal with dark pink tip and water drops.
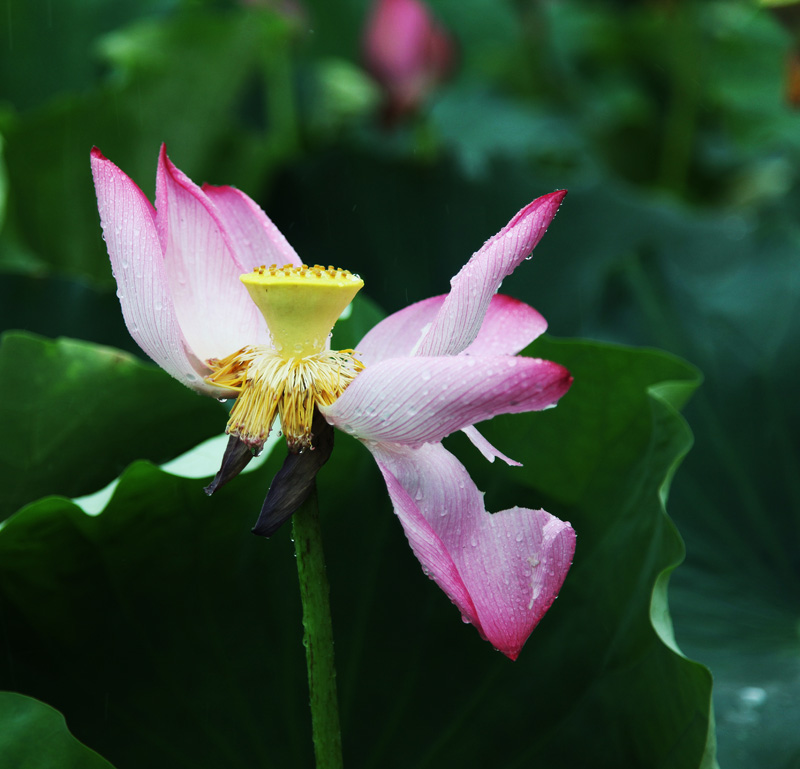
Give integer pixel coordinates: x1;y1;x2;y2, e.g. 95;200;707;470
91;147;234;397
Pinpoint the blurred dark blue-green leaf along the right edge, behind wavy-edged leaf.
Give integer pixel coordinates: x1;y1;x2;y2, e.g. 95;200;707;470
512;176;800;769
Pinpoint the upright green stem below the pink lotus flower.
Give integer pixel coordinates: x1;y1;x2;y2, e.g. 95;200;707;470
292;488;342;769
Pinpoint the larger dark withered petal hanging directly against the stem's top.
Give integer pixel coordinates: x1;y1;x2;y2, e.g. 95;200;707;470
253;409;333;537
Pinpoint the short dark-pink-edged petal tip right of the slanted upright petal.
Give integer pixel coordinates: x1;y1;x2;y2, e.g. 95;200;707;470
462;294;547;355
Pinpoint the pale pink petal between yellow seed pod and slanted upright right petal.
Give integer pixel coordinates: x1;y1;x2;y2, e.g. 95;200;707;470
356;294;447;366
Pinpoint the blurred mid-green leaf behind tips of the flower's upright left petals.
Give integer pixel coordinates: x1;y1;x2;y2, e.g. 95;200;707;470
0;10;294;286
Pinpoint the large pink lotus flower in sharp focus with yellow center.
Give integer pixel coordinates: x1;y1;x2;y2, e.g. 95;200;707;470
91;148;575;659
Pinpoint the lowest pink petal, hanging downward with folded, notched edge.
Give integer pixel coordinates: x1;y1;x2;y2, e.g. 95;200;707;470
368;444;575;660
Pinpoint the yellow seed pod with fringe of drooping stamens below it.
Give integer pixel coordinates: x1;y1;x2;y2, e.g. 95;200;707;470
207;265;364;451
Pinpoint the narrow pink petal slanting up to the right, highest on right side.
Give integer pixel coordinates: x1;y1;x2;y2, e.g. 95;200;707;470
418;190;567;355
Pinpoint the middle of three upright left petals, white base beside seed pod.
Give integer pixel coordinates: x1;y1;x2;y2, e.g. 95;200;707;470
156;146;266;360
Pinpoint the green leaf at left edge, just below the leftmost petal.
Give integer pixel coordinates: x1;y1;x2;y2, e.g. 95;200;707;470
0;332;225;518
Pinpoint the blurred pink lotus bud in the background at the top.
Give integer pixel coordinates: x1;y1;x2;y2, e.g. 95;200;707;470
363;0;455;124
